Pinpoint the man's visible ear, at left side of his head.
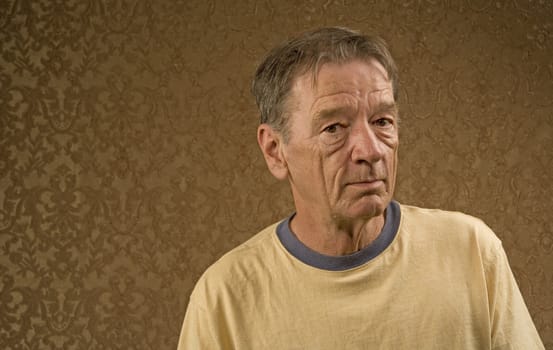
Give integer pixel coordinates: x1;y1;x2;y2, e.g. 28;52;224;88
257;124;288;180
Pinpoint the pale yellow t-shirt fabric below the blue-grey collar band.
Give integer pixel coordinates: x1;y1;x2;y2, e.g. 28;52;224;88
178;205;544;350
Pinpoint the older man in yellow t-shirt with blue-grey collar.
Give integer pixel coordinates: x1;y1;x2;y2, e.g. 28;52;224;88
179;28;544;350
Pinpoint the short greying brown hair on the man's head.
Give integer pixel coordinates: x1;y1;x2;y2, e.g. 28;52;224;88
251;27;398;141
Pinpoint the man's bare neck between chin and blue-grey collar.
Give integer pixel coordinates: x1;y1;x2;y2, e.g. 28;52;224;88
290;212;385;256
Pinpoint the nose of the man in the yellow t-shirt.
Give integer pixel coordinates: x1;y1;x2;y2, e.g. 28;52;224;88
351;123;384;164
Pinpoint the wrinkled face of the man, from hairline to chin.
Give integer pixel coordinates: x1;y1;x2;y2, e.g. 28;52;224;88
282;60;398;220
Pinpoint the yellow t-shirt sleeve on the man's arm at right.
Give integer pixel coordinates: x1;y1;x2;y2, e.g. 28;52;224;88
486;242;544;350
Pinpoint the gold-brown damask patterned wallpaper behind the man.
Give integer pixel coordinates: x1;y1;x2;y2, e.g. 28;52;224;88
0;0;553;349
